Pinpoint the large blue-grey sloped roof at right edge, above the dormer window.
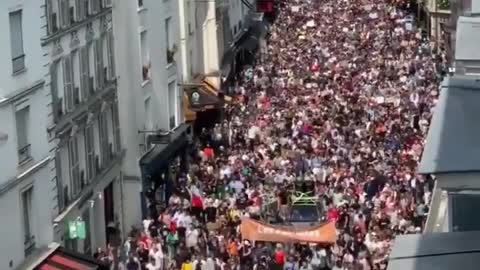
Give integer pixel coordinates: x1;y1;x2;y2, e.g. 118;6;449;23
419;76;480;173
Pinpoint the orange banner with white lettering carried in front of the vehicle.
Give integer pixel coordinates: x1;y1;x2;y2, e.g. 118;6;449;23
240;218;337;244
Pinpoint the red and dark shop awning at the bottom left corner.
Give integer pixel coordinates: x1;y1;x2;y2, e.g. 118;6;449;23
34;247;109;270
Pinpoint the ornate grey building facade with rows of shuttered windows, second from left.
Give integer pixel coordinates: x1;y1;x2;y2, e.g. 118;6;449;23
41;0;124;254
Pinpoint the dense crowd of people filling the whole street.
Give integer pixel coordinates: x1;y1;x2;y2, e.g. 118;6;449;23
112;0;442;270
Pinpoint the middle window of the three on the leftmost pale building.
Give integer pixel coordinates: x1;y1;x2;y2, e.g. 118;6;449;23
15;106;31;164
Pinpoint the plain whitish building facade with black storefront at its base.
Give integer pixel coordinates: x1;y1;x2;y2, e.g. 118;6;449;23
113;0;185;228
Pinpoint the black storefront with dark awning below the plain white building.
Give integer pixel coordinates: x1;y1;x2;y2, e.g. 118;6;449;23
140;124;192;218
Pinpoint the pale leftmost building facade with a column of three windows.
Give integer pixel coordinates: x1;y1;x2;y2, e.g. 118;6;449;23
0;0;55;269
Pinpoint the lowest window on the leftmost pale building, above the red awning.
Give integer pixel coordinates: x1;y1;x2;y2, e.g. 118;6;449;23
21;187;35;255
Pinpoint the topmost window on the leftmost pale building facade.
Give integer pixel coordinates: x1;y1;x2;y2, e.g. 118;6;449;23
9;10;25;74
